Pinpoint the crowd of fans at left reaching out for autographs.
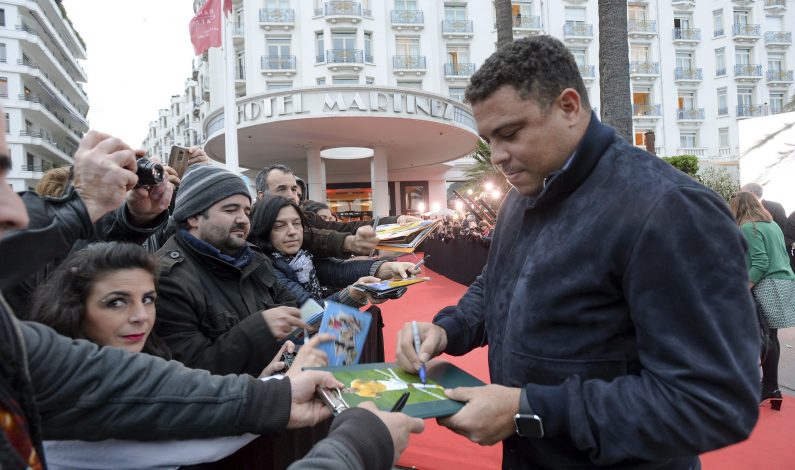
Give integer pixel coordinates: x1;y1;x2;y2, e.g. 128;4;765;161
0;129;430;469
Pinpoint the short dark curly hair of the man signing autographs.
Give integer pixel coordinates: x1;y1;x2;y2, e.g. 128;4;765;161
464;36;591;110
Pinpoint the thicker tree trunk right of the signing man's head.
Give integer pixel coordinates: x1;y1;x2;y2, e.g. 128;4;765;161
599;0;634;144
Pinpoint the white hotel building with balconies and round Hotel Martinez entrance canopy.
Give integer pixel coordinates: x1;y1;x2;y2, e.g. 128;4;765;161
150;0;795;217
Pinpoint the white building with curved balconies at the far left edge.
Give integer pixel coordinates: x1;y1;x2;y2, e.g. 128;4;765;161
0;0;88;191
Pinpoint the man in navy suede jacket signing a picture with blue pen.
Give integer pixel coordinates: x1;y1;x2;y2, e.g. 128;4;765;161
397;36;760;470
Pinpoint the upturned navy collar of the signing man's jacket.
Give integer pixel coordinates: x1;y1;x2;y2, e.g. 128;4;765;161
526;111;616;209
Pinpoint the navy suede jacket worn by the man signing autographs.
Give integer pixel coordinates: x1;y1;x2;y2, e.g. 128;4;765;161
434;115;760;469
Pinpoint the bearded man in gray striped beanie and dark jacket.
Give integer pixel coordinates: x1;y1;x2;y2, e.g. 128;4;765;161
156;165;306;376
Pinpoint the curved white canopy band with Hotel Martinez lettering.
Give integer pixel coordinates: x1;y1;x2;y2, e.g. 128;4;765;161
206;86;477;136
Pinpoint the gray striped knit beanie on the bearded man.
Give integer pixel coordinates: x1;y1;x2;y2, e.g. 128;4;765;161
171;165;251;223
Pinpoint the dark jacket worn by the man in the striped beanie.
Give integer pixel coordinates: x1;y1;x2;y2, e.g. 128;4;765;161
155;232;297;376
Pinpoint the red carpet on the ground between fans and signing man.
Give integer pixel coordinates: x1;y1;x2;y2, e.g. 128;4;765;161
381;262;795;470
